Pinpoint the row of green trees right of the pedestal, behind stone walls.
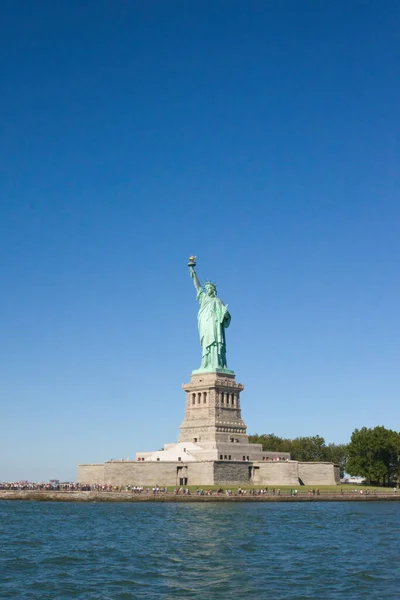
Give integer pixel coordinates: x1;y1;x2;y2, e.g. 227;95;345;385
249;425;400;485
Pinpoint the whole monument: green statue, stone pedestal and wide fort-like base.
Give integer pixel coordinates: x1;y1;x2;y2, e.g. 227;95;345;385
78;256;339;486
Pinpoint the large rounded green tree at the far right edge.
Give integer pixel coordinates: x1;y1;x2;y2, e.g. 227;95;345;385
347;426;400;485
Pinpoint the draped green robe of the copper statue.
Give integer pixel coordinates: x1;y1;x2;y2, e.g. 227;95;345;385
197;289;231;369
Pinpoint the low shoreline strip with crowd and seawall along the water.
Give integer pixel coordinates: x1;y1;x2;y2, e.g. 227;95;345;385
0;490;400;503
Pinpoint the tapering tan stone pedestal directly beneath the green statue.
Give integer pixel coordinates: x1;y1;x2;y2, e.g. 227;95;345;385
179;370;248;446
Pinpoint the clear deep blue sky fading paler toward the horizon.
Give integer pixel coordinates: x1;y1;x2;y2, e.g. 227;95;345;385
0;0;400;480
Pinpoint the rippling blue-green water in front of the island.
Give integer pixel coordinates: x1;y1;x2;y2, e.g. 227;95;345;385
0;501;400;600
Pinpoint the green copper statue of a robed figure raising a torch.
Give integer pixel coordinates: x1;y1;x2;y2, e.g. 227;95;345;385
188;256;233;373
